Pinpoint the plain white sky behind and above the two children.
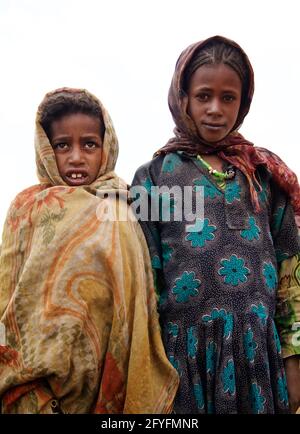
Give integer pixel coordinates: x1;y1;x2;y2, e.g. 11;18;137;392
0;0;300;231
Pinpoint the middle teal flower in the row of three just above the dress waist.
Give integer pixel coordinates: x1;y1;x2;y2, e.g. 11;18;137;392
218;255;250;286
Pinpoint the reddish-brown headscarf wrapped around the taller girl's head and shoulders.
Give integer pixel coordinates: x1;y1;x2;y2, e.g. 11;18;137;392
156;36;300;216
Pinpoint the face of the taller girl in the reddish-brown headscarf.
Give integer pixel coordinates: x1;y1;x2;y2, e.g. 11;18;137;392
187;63;242;143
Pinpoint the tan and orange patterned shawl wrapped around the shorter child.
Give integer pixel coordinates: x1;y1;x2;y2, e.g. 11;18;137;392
0;88;178;413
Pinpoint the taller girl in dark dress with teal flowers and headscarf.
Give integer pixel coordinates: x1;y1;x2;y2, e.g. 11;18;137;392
133;36;300;413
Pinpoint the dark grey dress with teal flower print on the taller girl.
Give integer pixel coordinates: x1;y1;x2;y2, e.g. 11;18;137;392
133;152;300;413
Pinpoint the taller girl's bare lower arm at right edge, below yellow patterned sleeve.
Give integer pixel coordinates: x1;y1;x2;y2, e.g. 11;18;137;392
284;356;300;413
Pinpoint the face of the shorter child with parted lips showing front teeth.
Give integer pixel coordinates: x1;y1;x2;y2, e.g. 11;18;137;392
50;113;102;186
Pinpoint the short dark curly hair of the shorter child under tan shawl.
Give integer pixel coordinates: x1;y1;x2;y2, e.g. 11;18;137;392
38;88;105;140
